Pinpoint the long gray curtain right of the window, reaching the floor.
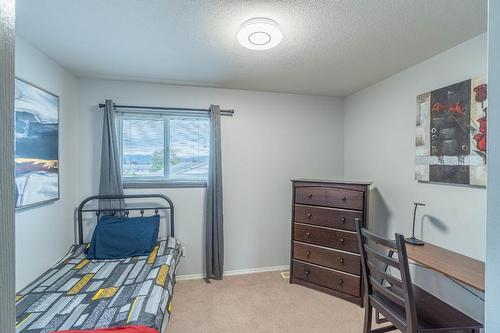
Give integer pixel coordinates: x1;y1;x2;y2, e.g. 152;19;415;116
205;105;224;279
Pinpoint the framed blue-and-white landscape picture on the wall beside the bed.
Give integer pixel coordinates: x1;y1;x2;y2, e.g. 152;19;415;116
15;78;59;208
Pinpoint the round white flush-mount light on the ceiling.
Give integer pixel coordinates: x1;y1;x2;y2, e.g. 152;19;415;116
238;17;283;50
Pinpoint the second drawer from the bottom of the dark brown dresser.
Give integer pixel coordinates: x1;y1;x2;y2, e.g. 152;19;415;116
293;242;361;275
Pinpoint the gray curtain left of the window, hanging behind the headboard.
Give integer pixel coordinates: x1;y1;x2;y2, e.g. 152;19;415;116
99;99;125;210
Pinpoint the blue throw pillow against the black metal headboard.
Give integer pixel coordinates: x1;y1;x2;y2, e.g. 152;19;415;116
87;215;160;259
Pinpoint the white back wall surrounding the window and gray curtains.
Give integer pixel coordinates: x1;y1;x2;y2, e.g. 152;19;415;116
78;79;344;275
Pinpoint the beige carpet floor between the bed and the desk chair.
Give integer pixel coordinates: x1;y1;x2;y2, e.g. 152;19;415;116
167;272;388;333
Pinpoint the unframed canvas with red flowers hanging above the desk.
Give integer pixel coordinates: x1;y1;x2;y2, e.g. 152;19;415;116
415;77;488;186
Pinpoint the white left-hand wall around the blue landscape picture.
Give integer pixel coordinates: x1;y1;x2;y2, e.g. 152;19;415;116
16;36;78;290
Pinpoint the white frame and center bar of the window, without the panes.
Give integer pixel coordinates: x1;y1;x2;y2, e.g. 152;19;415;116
115;109;210;188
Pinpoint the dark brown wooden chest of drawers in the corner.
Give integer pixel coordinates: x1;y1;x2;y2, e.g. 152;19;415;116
290;180;370;305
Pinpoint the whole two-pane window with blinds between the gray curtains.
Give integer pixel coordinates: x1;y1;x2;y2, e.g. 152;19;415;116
117;111;210;186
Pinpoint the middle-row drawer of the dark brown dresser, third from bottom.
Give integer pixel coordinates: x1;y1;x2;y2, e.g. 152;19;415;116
294;223;359;253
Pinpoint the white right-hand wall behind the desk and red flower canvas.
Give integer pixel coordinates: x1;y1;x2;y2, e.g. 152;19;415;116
344;35;486;320
